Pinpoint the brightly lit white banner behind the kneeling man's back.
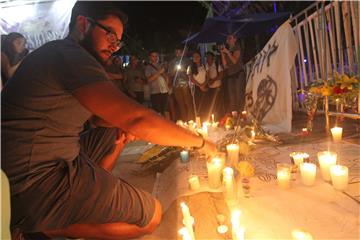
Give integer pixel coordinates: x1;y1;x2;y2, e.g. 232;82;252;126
0;0;76;50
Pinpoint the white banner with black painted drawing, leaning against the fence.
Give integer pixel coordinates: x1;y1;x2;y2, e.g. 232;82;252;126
246;21;297;133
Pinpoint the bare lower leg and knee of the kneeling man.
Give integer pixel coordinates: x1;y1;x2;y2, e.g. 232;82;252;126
44;200;161;240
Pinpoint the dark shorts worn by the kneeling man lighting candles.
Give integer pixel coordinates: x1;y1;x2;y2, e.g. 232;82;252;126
11;128;155;232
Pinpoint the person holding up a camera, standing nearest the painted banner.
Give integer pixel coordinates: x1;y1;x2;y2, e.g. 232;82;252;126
220;34;246;112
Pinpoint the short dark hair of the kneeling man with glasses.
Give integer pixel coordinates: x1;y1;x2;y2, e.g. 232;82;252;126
69;1;128;32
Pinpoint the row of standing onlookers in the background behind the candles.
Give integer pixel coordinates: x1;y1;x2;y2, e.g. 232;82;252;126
97;34;246;124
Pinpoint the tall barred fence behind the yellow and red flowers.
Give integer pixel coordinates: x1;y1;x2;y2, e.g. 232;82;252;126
291;1;360;129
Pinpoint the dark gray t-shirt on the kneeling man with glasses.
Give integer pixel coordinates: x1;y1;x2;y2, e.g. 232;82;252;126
1;39;110;193
